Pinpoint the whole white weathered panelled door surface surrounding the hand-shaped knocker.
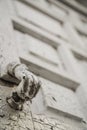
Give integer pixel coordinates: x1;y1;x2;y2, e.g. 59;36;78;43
0;0;87;130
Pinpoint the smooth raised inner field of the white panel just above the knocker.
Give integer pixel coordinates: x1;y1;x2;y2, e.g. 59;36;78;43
26;35;59;65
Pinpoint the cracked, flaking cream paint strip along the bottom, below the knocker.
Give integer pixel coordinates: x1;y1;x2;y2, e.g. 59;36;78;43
0;81;86;130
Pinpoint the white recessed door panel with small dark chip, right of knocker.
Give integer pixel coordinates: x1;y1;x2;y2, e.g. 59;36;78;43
36;78;82;119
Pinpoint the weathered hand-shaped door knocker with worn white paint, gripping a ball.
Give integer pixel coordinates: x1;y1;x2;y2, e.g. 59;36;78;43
6;62;41;110
